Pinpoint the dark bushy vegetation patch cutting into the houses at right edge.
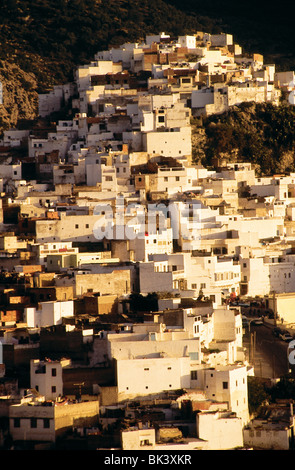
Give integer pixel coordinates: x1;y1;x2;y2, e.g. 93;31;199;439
193;103;295;175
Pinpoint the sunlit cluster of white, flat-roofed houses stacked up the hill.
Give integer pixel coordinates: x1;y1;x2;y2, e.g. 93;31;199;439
0;33;295;450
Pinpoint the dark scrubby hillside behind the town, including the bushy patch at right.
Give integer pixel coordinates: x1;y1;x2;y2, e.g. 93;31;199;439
0;0;295;173
